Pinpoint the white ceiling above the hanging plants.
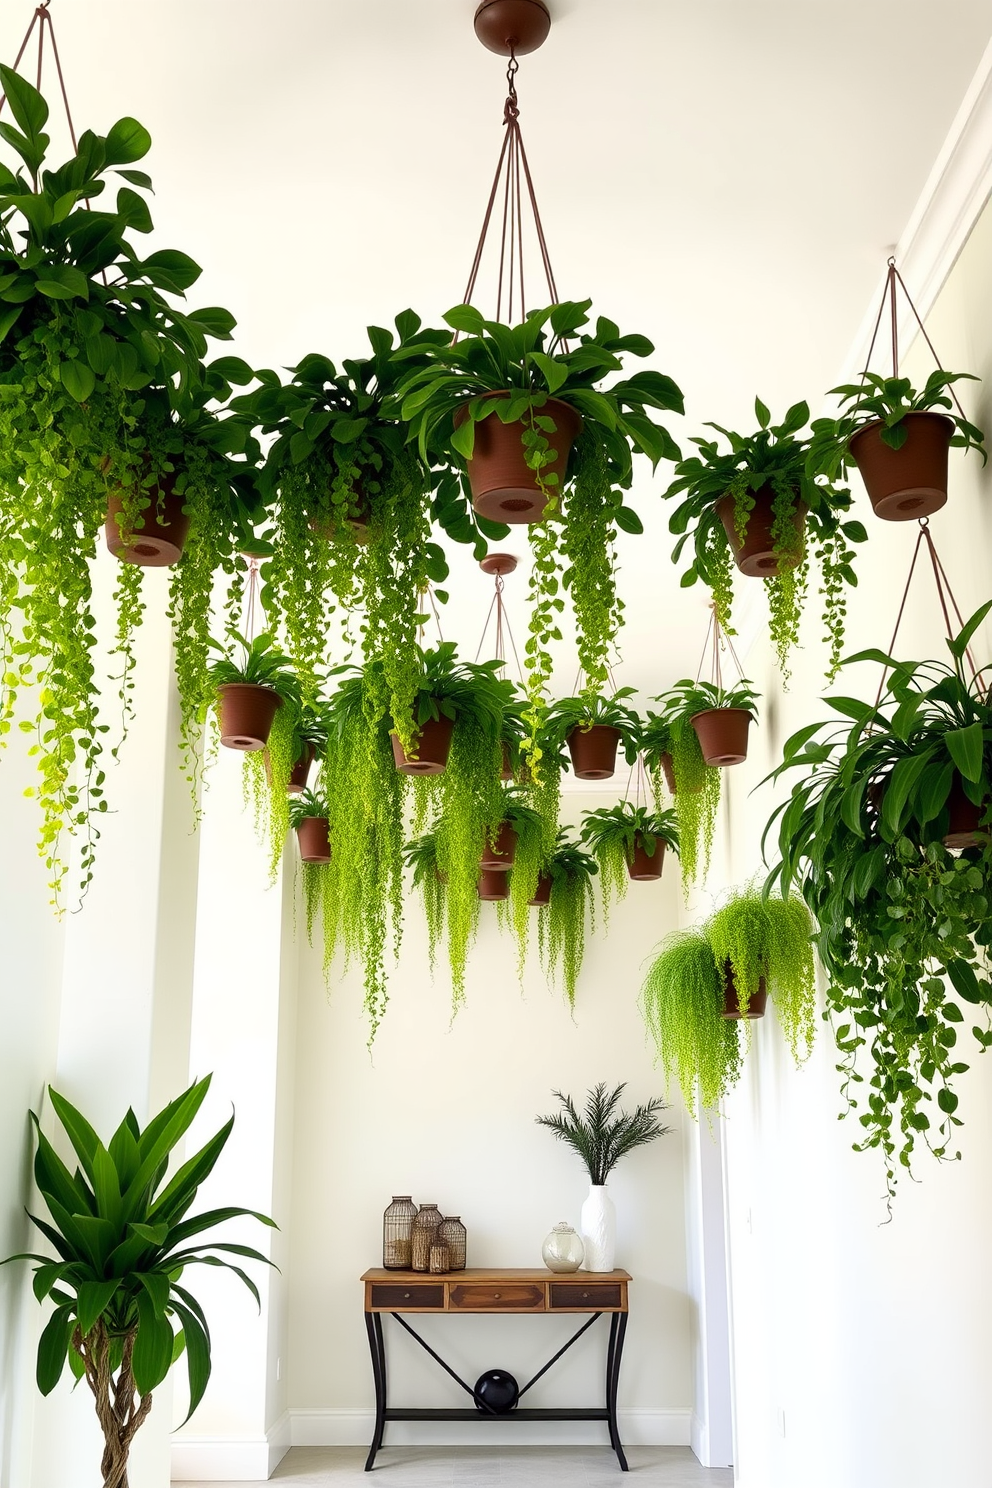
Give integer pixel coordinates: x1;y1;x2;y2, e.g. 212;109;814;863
0;0;992;711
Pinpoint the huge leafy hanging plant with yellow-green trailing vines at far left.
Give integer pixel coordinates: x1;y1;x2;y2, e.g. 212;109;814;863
0;68;248;905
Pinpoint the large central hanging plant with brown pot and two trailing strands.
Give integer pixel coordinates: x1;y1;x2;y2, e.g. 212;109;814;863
399;301;683;737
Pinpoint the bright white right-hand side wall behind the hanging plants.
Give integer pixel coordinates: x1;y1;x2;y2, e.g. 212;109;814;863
724;197;992;1488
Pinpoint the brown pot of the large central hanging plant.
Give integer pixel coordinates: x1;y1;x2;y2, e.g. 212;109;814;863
455;393;582;525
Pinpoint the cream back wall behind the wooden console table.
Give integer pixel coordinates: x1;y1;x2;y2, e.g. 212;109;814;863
282;793;692;1443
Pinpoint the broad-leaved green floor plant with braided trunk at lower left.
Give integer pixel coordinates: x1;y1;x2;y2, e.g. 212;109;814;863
3;1076;274;1488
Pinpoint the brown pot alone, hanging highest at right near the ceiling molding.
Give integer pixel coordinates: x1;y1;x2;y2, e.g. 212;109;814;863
848;412;955;522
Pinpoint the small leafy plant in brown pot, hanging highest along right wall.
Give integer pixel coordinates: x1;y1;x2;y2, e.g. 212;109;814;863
808;369;988;522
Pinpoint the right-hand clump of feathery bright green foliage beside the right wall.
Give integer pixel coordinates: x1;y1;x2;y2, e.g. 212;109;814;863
706;887;817;1064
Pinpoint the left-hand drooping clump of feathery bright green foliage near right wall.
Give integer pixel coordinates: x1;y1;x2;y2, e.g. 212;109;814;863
641;930;741;1116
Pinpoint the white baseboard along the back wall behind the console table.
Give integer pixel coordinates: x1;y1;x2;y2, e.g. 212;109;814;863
290;1406;692;1446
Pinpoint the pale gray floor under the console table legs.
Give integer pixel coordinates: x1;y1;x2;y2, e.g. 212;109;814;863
173;1446;733;1488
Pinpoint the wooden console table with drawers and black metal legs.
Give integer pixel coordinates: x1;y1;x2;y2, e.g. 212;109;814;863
361;1268;631;1472
